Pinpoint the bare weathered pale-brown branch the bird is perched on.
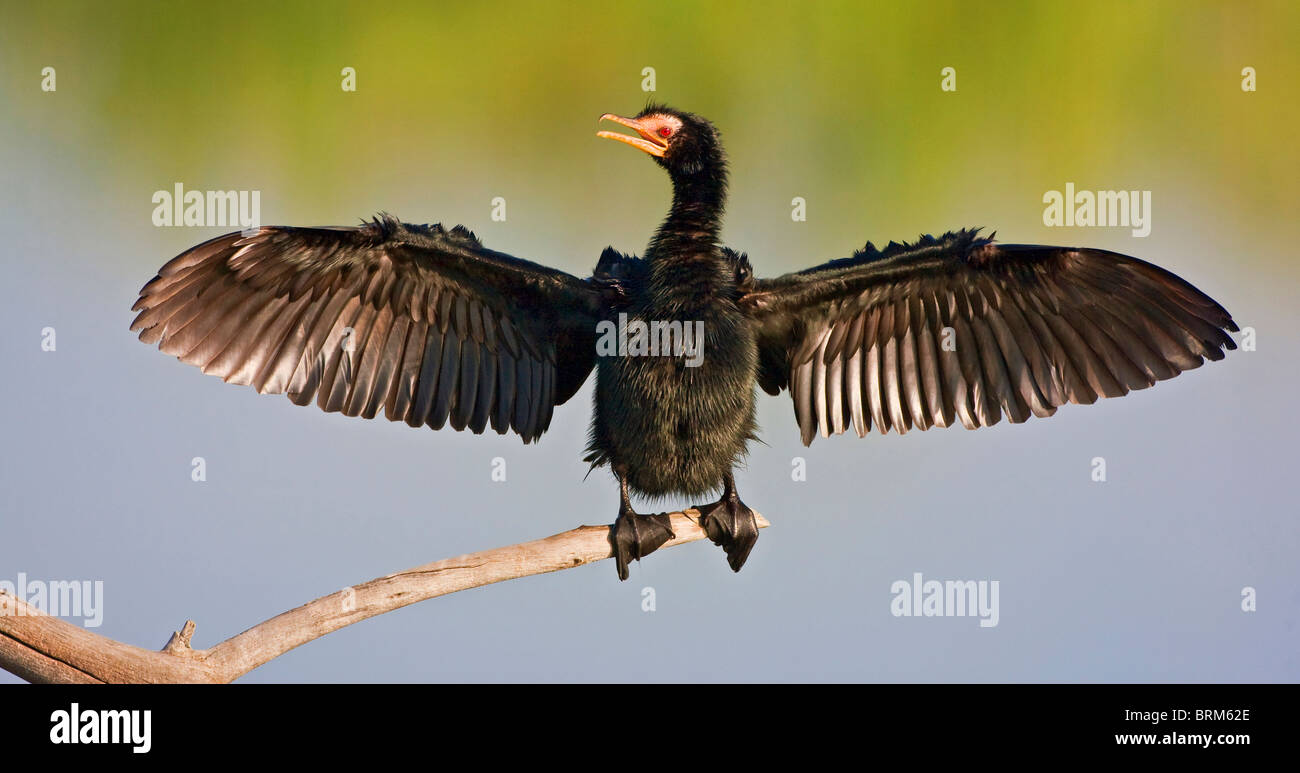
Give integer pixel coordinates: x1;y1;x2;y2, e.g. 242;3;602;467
0;509;768;683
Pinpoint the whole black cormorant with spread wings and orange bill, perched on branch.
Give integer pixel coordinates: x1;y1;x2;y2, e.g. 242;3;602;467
131;105;1238;579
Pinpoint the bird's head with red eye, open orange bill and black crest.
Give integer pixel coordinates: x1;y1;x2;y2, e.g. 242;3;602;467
597;104;723;178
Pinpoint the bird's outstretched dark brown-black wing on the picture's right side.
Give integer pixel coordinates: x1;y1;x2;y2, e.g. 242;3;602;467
741;230;1238;444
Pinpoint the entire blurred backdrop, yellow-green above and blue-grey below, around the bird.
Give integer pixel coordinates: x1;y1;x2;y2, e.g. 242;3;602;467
0;3;1300;682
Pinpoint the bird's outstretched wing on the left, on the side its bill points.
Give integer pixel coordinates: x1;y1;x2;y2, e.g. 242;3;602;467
131;216;599;443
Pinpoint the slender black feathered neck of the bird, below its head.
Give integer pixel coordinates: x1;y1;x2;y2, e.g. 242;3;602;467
646;166;727;266
